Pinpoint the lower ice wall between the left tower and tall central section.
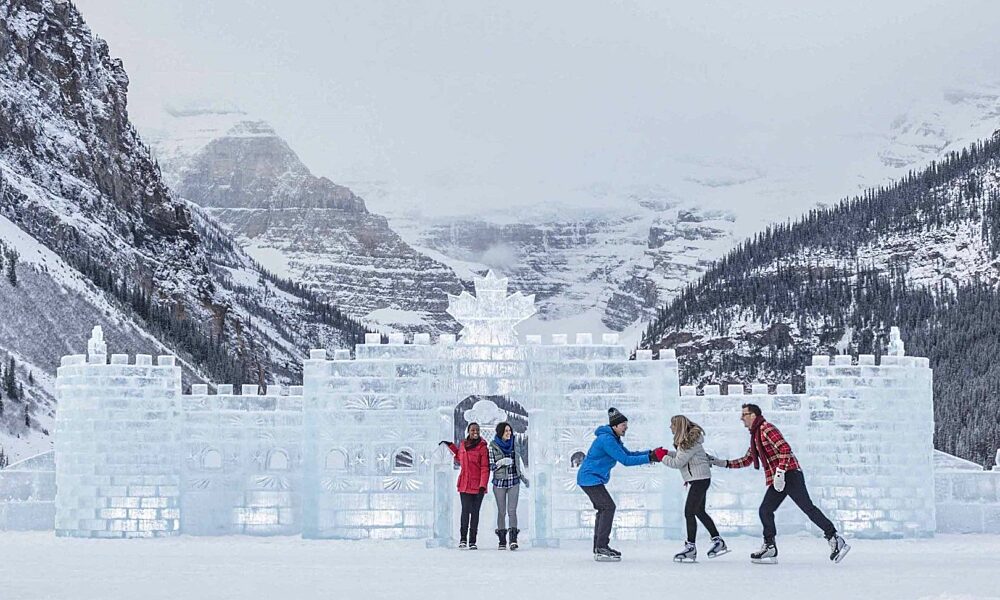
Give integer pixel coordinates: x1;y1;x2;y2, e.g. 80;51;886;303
180;385;303;535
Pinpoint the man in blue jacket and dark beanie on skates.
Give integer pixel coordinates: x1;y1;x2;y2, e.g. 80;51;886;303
576;407;667;562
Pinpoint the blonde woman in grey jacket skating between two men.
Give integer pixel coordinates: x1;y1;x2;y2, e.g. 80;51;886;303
663;415;729;562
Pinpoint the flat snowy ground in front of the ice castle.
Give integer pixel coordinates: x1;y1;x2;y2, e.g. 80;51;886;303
0;532;1000;600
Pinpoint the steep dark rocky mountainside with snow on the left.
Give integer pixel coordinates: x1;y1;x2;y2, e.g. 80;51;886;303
0;0;364;460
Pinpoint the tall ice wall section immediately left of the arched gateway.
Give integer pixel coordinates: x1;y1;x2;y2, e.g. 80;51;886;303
303;335;440;539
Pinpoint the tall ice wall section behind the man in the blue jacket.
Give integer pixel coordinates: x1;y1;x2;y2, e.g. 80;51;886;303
527;334;681;540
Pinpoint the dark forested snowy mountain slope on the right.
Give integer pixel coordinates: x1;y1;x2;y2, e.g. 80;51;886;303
643;131;1000;464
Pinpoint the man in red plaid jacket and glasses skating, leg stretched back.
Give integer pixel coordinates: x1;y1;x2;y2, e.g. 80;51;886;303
710;404;851;563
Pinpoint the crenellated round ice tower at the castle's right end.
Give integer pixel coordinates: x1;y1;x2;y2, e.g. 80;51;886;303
799;355;936;537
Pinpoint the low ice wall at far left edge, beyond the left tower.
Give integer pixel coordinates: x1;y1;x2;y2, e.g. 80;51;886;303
0;452;56;531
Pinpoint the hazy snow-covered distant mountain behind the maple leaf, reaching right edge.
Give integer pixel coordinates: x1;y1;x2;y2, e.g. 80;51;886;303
340;84;1000;340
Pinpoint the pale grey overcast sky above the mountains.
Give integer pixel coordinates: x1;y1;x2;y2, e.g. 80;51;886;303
76;0;1000;216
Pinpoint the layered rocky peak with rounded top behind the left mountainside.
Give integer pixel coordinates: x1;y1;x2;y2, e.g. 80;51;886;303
148;107;463;332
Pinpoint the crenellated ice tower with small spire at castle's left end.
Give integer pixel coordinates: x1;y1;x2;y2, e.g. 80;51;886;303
55;327;181;538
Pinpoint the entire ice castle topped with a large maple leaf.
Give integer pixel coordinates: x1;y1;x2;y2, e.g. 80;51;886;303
0;272;1000;546
